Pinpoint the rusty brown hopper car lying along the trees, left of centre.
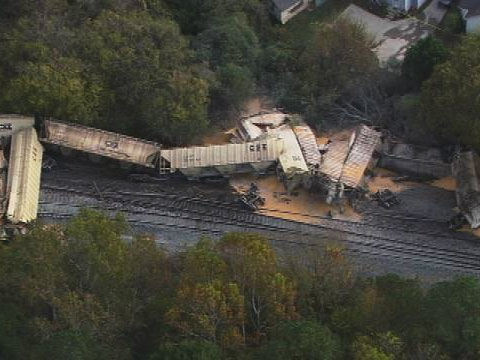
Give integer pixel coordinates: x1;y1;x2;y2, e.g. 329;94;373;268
42;120;160;168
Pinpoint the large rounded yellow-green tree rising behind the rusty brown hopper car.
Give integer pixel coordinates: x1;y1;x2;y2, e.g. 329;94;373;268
75;11;208;144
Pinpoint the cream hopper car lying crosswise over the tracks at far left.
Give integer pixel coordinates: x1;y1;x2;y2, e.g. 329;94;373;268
6;128;43;223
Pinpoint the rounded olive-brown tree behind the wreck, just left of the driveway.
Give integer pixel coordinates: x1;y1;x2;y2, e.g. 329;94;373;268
281;19;378;123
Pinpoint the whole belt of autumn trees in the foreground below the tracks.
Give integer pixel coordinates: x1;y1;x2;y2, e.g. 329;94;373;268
0;210;480;360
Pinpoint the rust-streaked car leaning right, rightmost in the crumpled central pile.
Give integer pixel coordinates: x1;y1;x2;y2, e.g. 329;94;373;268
340;126;380;187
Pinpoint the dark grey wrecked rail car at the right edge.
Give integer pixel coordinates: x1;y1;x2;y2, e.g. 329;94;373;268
452;151;480;228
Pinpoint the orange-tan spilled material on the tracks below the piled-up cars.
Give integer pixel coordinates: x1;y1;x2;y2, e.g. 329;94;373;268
230;176;360;223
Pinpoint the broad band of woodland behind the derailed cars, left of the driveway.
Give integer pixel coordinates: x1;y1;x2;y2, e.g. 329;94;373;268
0;0;382;145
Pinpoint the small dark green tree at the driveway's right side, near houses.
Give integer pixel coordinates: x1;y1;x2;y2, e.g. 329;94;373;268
402;36;448;89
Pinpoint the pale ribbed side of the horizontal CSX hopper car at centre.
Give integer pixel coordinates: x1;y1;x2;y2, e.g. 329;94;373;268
160;139;283;171
